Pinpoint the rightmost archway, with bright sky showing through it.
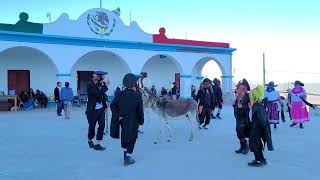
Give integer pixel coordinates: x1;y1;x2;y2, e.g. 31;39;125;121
192;57;226;89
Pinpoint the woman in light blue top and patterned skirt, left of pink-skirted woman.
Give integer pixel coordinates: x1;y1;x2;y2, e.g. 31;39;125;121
264;81;281;129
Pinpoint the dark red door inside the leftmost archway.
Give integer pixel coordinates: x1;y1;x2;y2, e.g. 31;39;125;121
8;70;30;95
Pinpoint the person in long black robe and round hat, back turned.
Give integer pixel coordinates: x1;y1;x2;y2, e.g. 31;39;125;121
110;73;144;166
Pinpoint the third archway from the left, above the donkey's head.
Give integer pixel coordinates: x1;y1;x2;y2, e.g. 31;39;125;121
141;54;184;94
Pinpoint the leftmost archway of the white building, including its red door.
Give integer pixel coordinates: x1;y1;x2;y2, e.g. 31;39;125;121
0;46;58;96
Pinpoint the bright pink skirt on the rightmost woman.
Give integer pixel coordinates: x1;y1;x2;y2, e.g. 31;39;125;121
291;102;309;124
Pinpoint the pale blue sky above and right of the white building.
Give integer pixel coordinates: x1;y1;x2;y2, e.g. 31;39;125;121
0;0;320;82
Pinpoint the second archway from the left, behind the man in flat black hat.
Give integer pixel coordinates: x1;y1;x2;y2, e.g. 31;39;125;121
71;50;131;96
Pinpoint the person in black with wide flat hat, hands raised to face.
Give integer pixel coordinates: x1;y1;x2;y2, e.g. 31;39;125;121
86;71;110;151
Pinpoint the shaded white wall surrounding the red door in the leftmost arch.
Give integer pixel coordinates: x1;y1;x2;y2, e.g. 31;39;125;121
0;47;57;96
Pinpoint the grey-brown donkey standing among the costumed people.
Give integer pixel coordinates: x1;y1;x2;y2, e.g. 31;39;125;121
142;89;198;144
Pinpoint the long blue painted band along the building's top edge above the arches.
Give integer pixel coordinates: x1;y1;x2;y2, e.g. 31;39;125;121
0;31;236;55
